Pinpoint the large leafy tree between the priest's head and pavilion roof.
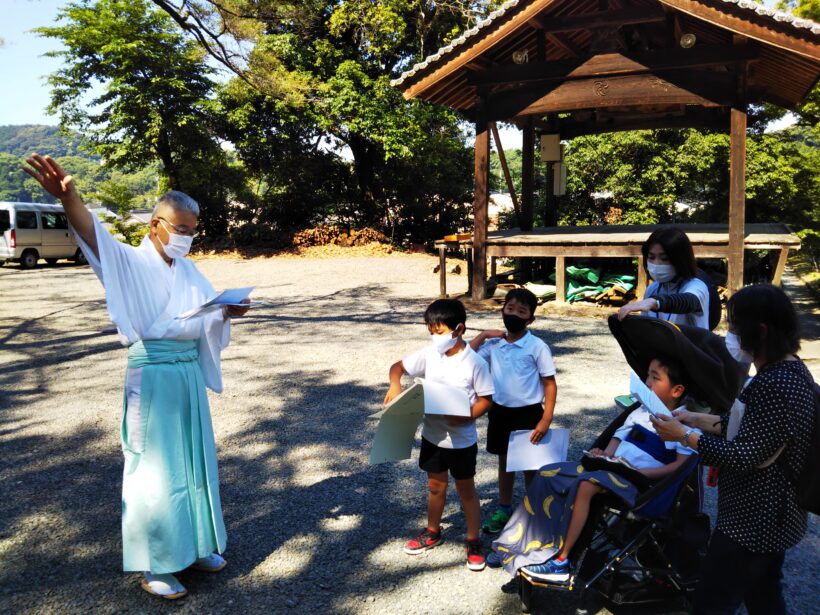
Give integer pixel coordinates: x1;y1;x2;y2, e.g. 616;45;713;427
149;0;478;239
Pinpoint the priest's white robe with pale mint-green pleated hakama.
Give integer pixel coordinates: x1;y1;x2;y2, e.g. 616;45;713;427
75;218;230;574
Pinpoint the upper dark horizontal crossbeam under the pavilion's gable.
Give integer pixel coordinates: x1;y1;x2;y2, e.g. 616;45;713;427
467;45;758;86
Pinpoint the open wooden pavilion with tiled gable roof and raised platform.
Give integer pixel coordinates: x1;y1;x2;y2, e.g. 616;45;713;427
393;0;820;299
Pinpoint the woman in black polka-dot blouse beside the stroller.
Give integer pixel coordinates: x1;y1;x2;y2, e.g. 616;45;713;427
653;284;815;615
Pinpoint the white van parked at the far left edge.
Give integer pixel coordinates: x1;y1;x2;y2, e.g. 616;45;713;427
0;201;86;269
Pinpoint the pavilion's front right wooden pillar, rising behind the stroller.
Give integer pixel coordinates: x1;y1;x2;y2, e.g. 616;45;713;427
727;108;746;294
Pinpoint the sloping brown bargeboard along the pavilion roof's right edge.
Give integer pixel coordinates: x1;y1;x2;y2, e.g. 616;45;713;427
659;0;820;61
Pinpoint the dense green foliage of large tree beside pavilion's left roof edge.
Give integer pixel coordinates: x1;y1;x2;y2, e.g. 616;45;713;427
151;0;478;241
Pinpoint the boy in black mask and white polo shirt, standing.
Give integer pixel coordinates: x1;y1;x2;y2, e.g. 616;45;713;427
470;288;558;534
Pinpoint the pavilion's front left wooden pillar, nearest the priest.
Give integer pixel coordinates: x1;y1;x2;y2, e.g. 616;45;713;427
471;97;490;301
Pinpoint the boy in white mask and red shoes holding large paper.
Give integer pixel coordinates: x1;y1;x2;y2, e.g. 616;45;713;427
384;299;493;571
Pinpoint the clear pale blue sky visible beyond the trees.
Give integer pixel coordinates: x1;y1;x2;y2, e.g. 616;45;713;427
0;0;796;139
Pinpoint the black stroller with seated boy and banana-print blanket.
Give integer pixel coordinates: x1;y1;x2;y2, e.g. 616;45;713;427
491;317;742;606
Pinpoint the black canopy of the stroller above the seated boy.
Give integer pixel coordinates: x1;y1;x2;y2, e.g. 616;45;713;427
609;314;745;414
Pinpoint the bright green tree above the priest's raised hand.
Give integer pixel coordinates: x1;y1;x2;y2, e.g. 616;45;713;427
38;0;235;236
